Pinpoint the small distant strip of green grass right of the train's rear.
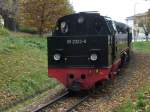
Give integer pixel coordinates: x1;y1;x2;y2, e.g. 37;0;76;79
133;41;150;53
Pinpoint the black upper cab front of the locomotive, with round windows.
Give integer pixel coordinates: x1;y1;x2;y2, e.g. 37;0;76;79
53;12;110;36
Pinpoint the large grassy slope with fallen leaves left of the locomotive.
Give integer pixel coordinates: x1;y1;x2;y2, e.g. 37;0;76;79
0;29;58;109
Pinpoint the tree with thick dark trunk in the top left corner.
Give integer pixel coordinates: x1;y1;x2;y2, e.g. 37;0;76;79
0;0;18;31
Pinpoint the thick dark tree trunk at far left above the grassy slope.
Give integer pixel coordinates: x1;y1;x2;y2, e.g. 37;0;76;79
3;16;17;31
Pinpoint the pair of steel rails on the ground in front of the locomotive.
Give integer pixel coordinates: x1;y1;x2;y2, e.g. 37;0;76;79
33;91;92;112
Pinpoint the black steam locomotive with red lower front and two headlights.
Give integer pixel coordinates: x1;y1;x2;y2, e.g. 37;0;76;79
48;12;132;91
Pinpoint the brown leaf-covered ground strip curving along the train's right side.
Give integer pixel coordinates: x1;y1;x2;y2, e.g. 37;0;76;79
77;53;150;112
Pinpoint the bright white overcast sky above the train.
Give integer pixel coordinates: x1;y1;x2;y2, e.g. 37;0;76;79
70;0;150;22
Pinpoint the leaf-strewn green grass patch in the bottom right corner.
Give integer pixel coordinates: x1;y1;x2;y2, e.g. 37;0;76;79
113;82;150;112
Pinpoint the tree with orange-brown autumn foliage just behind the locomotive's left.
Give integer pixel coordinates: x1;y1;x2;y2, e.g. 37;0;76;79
19;0;73;35
